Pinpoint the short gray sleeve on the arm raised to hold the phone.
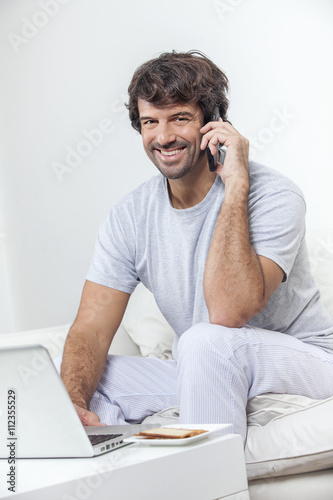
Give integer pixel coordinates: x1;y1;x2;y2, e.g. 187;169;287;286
249;190;306;281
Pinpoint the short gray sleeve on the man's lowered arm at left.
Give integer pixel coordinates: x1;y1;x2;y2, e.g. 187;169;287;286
87;209;140;294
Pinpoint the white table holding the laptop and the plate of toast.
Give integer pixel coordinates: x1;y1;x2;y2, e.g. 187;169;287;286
0;434;249;500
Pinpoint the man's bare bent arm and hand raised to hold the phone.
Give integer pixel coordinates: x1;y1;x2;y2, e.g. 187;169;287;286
201;121;283;327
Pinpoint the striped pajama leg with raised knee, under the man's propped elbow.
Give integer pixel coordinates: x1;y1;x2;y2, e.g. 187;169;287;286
178;323;333;440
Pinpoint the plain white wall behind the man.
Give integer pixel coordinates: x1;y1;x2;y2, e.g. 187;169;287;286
0;0;333;333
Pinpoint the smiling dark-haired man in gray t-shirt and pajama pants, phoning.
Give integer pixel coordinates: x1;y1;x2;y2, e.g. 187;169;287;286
61;52;333;440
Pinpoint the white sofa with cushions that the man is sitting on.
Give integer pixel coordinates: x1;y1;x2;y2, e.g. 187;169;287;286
0;230;333;500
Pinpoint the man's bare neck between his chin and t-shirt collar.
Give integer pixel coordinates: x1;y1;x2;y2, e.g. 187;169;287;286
168;168;216;209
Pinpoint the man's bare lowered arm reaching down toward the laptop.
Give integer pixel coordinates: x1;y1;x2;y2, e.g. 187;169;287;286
61;281;130;412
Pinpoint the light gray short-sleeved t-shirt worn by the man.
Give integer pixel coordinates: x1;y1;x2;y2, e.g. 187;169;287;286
87;162;333;354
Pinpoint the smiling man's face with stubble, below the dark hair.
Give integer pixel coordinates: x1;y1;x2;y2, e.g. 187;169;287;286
138;99;207;179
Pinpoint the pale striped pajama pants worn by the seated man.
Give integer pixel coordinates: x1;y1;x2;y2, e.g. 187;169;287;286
55;323;333;440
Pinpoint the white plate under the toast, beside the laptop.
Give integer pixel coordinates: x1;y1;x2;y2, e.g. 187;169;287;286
124;424;232;446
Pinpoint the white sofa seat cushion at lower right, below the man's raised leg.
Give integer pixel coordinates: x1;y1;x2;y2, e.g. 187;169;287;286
245;394;333;479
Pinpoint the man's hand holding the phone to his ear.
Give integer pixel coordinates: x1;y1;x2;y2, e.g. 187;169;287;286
200;118;249;193
